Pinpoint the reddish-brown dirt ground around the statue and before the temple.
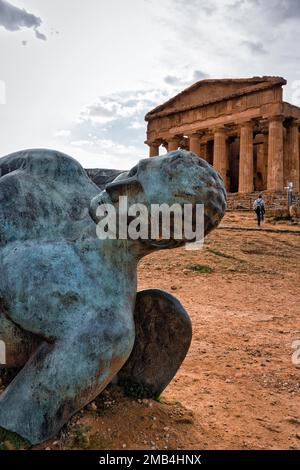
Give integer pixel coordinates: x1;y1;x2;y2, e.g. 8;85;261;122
0;212;300;449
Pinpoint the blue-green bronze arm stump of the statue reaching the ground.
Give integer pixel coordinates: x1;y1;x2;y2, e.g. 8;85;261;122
0;310;133;444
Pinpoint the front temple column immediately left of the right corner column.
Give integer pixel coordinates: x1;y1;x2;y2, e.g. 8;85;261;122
238;121;254;193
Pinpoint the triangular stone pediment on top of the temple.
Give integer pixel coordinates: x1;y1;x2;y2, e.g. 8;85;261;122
146;77;286;121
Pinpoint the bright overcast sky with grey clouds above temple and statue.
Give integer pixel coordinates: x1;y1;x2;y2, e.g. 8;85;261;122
0;0;300;169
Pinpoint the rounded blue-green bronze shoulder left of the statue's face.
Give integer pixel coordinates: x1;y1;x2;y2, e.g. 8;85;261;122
0;149;99;245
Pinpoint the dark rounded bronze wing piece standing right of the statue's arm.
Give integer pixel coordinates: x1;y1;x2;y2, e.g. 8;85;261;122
117;289;192;398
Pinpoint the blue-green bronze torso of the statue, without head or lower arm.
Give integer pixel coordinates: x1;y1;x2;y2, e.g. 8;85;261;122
0;150;136;360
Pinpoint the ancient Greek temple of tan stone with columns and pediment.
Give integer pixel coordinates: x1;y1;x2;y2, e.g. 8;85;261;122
145;77;300;193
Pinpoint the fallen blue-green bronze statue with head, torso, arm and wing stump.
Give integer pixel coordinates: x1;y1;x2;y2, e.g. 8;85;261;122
0;149;226;444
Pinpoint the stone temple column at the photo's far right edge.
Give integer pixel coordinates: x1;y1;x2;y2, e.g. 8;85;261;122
284;120;300;191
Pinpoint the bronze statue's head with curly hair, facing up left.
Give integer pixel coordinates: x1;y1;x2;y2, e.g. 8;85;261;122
90;150;226;252
